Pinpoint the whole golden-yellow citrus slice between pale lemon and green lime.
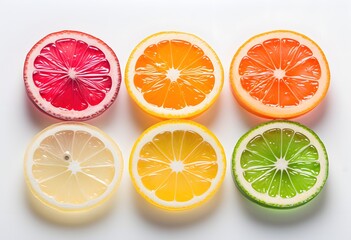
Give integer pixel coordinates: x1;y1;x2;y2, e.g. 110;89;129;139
129;120;226;210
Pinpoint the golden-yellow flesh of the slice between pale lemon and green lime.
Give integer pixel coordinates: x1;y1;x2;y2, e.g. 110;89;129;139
137;130;218;202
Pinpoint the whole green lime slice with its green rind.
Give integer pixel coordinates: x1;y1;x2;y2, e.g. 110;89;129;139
233;121;328;208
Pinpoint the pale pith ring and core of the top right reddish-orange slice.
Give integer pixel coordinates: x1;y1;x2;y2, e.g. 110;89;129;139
230;31;329;118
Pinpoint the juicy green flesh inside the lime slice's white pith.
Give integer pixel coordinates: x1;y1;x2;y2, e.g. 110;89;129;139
240;128;320;199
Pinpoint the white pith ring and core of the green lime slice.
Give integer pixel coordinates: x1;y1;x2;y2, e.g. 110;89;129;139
233;122;328;207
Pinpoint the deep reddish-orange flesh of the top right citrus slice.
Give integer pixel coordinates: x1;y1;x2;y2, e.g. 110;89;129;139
239;38;321;108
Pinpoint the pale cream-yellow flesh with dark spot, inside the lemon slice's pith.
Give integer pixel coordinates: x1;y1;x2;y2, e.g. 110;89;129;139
32;131;115;204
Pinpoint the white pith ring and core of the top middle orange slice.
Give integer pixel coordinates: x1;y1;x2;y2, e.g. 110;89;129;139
126;32;223;118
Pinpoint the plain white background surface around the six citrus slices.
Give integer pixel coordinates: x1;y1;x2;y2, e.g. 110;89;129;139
0;0;351;240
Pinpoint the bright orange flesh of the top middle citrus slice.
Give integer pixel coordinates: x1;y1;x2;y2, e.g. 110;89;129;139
134;39;215;110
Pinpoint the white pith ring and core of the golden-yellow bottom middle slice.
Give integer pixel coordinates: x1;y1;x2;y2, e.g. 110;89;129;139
130;121;226;209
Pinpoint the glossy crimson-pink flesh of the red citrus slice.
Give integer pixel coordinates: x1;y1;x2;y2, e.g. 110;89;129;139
33;38;112;111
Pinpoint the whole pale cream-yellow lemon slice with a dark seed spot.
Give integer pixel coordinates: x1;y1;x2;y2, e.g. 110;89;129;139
24;122;123;212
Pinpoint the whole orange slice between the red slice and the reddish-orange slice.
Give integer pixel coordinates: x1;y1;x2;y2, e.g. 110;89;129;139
125;32;223;118
